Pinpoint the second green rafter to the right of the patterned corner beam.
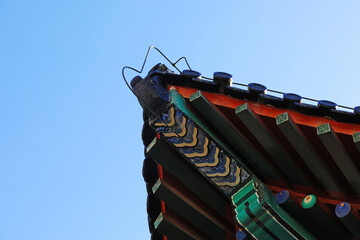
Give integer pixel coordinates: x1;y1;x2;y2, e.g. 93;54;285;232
235;103;311;186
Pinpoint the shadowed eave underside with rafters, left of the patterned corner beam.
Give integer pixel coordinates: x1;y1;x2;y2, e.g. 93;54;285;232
142;118;236;240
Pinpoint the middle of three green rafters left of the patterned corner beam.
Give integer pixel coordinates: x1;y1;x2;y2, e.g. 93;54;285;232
152;179;226;240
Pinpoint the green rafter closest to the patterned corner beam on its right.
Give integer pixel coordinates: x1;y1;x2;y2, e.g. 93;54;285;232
190;91;279;179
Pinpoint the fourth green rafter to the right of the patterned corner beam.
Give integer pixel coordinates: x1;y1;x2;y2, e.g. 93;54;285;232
316;123;360;194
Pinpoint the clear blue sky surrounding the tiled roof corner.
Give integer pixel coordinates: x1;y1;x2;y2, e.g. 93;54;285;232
0;0;360;240
